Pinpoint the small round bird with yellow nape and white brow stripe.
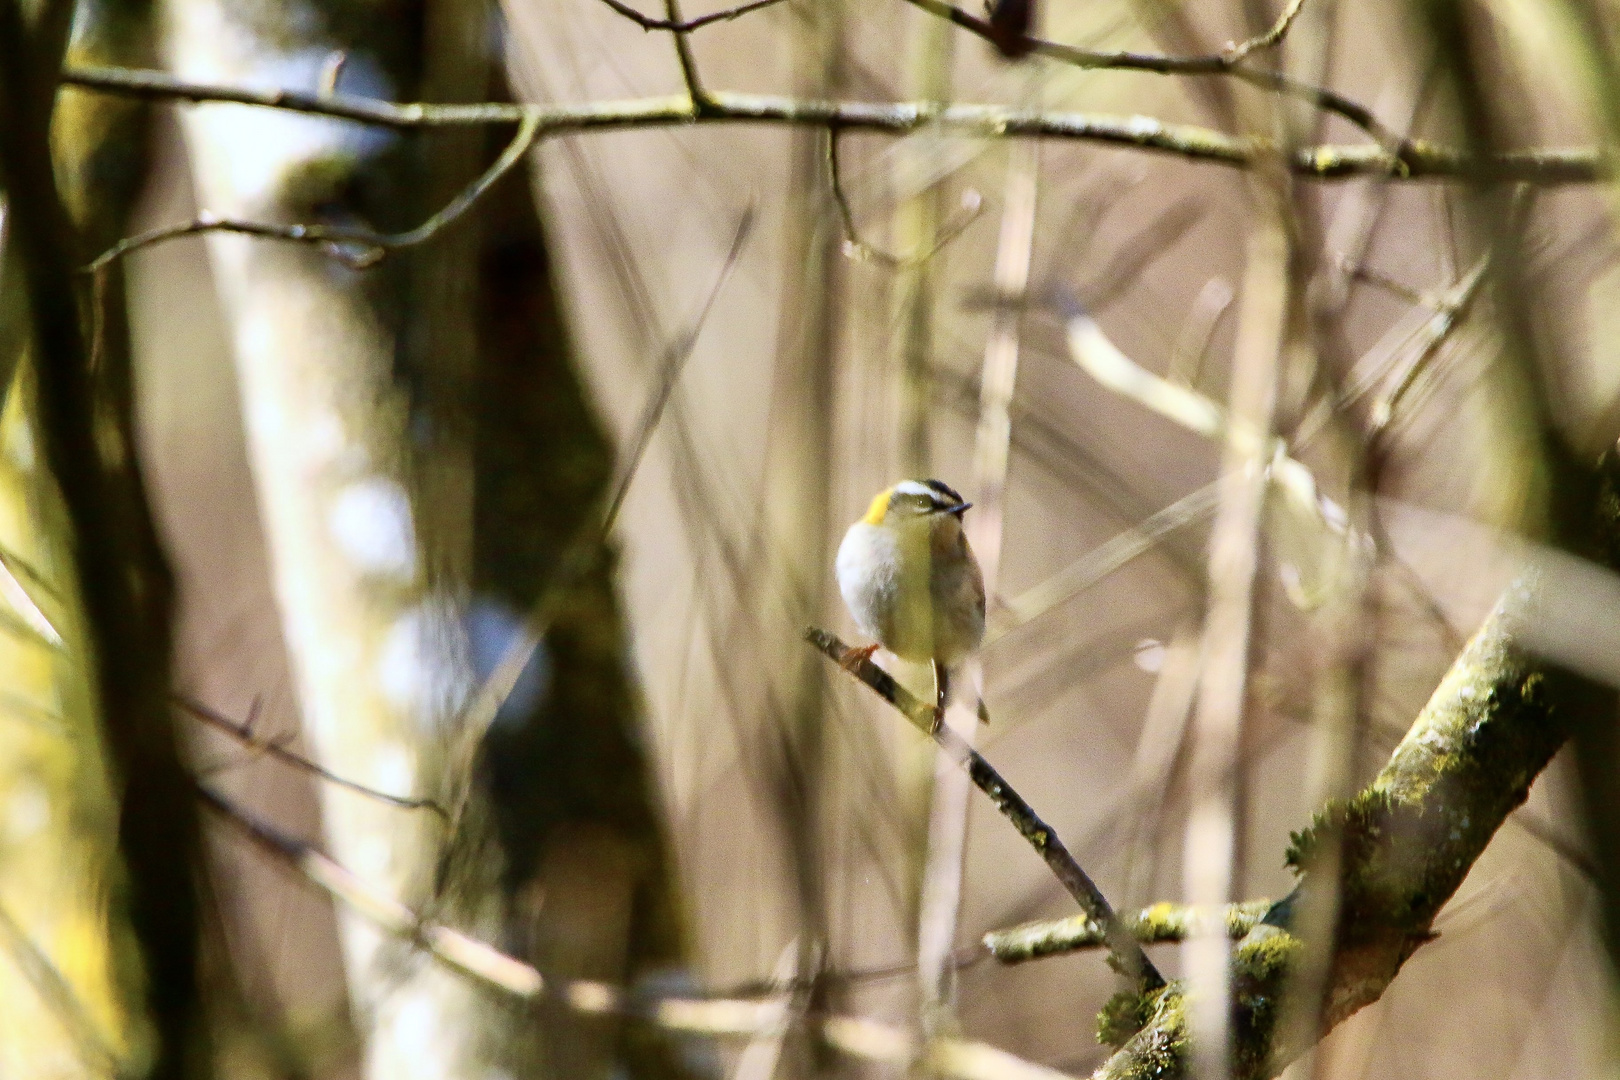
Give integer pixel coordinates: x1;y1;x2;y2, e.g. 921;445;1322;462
836;479;985;724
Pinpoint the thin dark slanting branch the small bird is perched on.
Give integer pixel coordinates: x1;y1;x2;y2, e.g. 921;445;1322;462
805;627;1165;993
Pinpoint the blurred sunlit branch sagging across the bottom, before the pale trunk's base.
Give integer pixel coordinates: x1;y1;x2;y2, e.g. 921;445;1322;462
196;787;1069;1080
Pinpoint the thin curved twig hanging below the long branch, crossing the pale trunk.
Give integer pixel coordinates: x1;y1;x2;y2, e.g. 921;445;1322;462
84;110;541;277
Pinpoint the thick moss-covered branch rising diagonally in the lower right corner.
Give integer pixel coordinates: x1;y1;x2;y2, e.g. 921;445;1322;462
1095;575;1602;1080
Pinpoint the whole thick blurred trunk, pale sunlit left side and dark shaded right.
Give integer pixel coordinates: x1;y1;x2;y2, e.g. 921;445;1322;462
159;0;703;1078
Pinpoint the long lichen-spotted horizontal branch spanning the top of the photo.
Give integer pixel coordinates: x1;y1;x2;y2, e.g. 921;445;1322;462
63;68;1610;186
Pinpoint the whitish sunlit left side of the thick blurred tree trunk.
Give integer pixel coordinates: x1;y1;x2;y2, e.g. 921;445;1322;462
167;0;504;1080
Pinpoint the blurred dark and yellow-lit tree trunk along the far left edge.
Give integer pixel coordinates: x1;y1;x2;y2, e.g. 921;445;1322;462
0;0;211;1077
